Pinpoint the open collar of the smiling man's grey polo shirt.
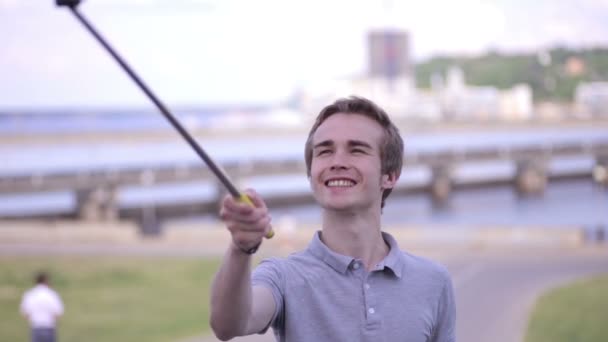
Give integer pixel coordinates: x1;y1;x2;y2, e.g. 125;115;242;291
308;231;405;278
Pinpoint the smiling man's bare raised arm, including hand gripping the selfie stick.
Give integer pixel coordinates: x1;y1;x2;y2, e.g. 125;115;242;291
211;192;275;341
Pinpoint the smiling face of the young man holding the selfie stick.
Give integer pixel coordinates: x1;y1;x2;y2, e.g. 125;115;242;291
310;113;395;211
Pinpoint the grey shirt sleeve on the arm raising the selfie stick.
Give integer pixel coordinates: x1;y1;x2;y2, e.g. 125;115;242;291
251;258;285;334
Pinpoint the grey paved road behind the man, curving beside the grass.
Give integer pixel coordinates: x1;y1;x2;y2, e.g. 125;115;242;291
191;247;608;342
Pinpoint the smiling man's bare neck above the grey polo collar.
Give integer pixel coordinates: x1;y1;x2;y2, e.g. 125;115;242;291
321;210;389;270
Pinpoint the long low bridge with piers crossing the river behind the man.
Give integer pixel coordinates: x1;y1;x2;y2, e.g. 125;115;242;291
0;139;608;234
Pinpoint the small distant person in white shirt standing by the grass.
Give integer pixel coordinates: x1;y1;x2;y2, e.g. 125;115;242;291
20;272;63;342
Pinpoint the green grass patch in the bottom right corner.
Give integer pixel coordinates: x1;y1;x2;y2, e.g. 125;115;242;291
526;275;608;342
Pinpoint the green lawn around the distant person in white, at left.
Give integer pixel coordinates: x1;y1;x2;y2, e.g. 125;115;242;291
0;257;219;342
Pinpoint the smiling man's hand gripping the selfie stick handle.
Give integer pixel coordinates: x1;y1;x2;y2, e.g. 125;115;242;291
220;189;271;251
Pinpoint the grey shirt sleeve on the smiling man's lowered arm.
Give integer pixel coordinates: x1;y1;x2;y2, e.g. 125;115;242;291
432;272;456;342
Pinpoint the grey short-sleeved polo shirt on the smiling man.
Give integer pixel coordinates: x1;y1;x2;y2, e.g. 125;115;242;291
252;232;456;342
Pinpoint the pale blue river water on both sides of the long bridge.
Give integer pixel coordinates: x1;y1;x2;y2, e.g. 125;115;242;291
0;112;608;226
